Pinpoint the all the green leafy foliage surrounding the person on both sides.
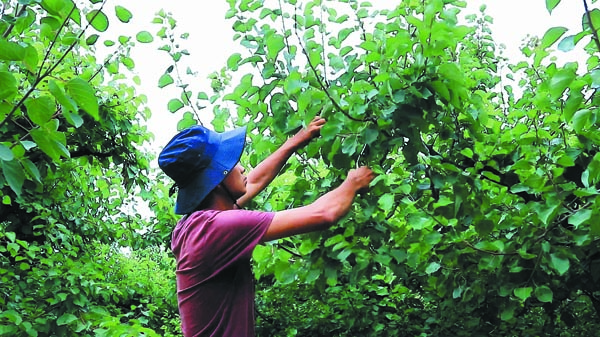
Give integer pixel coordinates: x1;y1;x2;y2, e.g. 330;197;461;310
0;0;600;336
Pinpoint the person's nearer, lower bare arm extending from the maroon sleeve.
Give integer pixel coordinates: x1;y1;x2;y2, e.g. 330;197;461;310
262;167;374;242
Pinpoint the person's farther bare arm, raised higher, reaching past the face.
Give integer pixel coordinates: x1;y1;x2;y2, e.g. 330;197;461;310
237;117;325;207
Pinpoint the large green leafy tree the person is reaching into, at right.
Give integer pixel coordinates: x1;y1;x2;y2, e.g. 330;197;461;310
198;0;600;336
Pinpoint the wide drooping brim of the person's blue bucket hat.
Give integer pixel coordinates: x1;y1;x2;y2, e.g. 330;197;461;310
175;126;246;214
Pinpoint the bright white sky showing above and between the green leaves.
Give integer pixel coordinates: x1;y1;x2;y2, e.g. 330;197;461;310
107;0;583;152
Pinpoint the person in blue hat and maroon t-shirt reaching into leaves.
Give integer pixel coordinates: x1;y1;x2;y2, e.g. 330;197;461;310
158;117;374;337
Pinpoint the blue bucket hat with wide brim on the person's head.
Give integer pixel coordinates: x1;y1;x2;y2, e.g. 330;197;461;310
158;125;246;214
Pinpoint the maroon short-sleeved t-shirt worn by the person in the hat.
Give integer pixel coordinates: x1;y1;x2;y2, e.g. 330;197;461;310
171;210;275;337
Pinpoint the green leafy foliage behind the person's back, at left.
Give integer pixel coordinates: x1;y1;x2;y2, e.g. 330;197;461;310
0;0;179;336
